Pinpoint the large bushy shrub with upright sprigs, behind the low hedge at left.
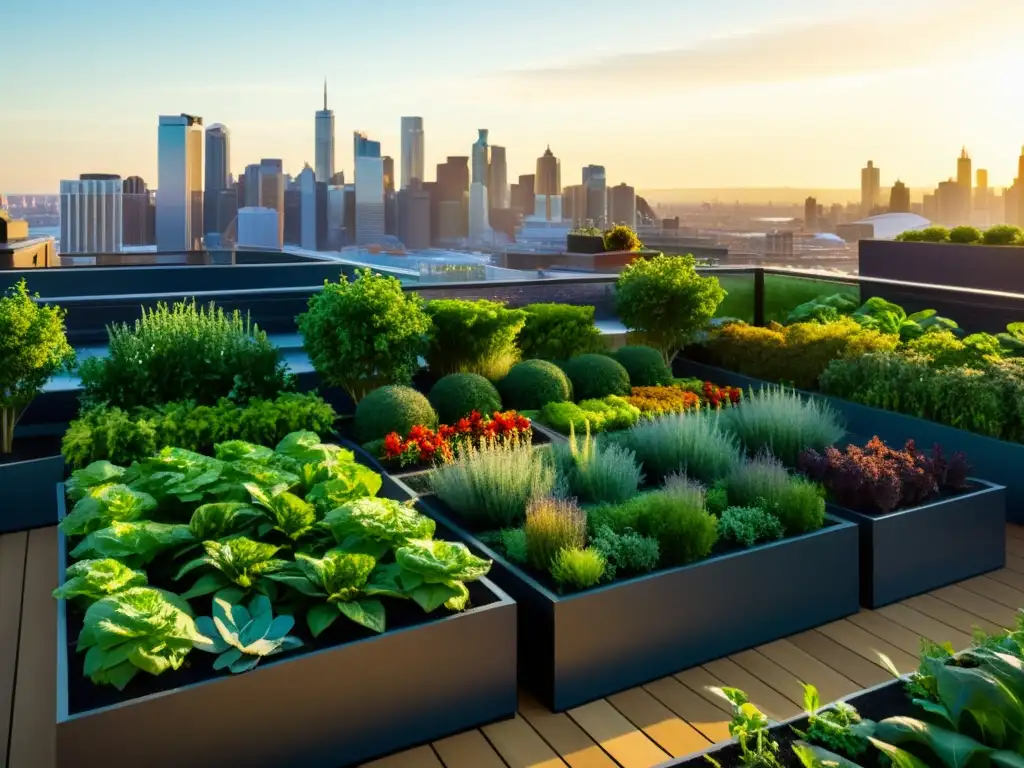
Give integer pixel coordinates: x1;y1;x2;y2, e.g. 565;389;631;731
79;300;292;409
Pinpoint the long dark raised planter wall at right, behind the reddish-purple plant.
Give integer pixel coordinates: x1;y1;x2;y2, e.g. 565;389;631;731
673;357;1024;524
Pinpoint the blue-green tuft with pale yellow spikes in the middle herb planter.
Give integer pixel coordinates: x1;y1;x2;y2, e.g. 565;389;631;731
552;425;643;503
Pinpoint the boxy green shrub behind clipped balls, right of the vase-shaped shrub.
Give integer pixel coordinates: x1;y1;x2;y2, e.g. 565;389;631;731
519;304;604;362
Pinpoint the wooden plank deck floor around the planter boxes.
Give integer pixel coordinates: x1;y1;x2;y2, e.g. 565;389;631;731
6;525;1024;768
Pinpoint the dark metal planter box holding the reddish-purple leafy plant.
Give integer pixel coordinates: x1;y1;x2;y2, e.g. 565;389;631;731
828;480;1007;608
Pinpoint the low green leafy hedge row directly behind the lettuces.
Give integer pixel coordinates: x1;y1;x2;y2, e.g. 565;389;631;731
60;392;338;467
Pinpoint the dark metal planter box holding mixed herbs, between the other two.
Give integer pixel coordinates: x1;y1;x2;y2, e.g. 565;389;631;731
398;480;858;712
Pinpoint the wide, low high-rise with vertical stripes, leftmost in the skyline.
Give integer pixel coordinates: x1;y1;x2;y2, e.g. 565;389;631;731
60;173;124;253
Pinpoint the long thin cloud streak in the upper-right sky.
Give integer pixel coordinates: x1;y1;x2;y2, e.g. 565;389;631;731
503;0;1024;88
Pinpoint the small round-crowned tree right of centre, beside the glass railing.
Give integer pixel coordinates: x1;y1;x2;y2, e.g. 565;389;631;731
615;254;725;366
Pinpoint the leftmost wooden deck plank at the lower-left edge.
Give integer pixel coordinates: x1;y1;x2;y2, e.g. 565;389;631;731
0;531;29;763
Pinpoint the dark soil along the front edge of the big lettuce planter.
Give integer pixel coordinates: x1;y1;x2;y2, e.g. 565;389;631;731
65;582;498;715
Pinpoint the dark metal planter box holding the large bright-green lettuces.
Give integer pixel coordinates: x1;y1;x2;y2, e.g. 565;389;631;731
50;485;516;768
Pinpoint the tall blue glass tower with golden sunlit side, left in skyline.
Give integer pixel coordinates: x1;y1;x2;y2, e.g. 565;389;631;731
157;114;203;251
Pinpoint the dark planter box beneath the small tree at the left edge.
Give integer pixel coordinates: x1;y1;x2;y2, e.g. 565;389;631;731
0;455;65;534
